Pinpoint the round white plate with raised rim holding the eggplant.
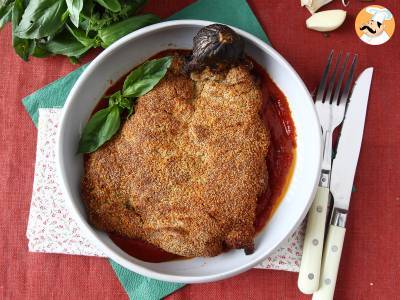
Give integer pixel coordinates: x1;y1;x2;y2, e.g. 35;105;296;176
57;20;321;283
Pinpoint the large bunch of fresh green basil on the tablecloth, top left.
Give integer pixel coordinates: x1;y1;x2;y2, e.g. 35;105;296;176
0;0;160;62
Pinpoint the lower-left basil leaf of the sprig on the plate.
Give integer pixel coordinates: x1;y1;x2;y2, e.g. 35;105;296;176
78;105;121;153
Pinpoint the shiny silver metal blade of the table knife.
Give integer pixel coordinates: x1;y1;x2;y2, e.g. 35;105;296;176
330;68;373;210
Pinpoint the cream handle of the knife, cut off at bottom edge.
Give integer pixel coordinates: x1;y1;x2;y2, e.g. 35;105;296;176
313;225;346;300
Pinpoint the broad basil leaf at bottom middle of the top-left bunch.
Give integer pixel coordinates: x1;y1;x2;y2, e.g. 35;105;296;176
44;31;91;58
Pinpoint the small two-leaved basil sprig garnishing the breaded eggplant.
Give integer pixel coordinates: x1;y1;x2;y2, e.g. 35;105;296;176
78;56;172;153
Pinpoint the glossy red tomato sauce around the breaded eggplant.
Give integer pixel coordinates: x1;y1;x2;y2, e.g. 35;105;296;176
94;50;296;263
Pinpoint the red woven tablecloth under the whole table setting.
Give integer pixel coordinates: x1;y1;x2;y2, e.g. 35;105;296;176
0;0;400;299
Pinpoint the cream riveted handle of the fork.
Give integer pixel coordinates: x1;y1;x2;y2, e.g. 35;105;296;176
297;187;329;294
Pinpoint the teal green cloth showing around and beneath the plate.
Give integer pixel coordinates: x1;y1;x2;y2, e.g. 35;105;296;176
22;0;269;300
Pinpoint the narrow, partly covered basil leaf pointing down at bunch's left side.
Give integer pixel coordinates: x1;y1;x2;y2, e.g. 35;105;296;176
12;0;31;61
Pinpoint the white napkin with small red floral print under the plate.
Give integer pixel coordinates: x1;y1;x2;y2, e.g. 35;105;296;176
26;109;304;272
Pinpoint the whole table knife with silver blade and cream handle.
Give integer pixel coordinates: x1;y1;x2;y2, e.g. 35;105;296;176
313;68;373;300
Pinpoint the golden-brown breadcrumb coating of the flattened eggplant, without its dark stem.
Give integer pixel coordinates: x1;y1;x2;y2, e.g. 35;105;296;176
82;56;270;257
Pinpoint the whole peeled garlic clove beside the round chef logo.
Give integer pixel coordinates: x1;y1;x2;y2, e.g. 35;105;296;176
306;9;346;32
